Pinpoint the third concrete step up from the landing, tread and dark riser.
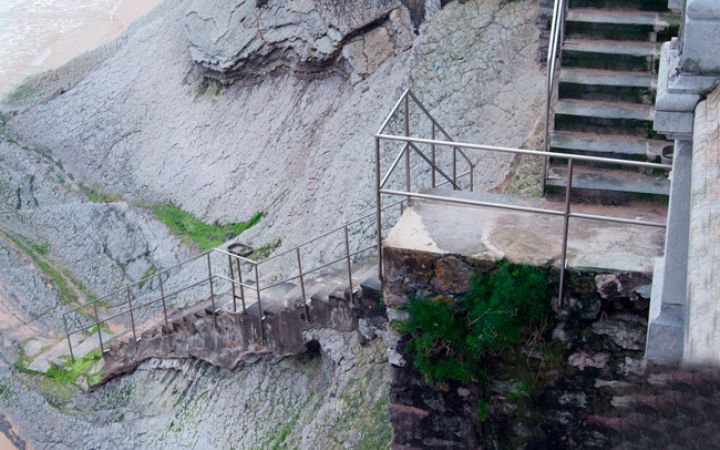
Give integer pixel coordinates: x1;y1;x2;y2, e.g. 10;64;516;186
555;99;655;137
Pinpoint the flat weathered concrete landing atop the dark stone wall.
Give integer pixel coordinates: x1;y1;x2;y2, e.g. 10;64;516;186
384;191;666;274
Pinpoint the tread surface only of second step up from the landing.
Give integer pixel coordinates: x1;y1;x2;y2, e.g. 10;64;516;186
550;131;672;156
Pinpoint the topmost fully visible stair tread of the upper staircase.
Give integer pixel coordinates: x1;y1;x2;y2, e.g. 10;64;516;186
566;8;680;29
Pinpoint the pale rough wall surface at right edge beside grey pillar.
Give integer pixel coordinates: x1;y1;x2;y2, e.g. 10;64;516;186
683;88;720;364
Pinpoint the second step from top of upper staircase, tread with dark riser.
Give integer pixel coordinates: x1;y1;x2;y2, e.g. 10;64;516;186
562;38;660;72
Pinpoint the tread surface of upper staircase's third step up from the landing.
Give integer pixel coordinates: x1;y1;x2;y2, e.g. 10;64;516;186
555;99;655;121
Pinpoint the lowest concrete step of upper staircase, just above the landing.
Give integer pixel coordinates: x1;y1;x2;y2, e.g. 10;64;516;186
547;166;670;201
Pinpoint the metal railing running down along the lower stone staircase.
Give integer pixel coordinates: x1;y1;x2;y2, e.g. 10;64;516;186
63;200;406;360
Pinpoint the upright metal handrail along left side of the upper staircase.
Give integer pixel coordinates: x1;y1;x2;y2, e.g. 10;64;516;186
542;0;567;192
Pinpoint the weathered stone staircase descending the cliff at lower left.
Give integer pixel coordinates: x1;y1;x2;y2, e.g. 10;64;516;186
103;263;383;381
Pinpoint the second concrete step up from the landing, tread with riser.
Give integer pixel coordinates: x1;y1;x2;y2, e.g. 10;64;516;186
550;131;672;165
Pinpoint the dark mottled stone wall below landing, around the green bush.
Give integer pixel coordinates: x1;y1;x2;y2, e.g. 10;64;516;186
385;248;719;449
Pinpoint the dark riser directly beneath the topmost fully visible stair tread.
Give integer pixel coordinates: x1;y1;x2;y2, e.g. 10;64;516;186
565;22;678;42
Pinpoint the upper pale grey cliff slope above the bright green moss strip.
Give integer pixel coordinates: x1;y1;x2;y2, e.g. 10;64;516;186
0;0;543;266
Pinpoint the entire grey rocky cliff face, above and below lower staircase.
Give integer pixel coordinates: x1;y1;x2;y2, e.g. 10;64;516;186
0;0;543;448
